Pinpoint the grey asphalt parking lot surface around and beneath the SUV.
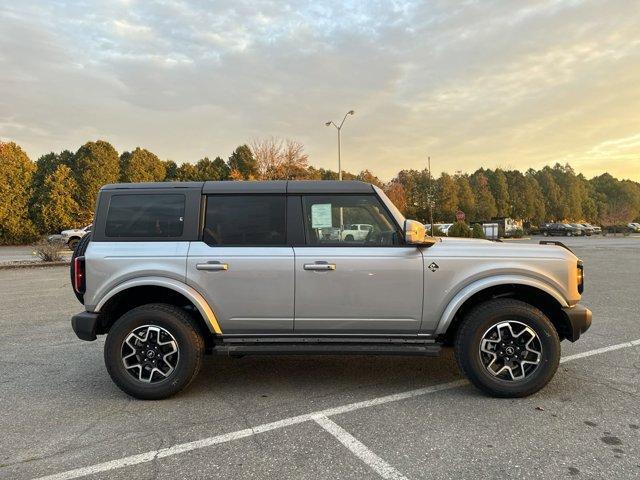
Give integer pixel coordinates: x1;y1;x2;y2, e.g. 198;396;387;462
0;237;640;479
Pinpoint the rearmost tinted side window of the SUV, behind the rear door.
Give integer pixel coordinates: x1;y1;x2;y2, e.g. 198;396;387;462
105;195;185;238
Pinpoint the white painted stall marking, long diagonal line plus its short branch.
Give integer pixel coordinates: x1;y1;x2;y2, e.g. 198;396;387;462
38;339;640;480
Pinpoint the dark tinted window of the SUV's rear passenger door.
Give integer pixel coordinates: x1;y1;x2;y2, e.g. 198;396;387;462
203;195;286;246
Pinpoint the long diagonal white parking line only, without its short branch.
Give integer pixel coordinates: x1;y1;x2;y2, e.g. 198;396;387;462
38;339;640;480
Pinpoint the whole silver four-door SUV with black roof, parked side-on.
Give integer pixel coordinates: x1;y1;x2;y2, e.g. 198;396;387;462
71;181;591;399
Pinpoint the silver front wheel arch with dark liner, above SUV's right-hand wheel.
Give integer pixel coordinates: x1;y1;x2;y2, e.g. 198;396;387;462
435;276;570;343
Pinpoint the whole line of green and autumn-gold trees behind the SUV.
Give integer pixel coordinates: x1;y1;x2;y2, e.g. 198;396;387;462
0;137;640;244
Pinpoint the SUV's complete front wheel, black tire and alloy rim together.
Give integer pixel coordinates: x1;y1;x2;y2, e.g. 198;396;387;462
455;299;560;397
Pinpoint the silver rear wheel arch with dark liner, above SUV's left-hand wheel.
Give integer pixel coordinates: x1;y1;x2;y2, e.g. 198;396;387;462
94;277;222;335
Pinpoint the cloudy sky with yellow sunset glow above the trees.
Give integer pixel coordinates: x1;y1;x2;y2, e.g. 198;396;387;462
0;0;640;180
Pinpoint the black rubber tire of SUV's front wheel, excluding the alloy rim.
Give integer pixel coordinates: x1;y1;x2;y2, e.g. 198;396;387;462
455;299;560;398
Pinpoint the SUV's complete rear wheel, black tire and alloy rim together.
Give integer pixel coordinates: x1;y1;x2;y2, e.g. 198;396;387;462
104;303;204;400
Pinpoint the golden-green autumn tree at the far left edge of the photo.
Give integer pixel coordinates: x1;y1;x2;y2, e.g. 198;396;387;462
0;142;36;244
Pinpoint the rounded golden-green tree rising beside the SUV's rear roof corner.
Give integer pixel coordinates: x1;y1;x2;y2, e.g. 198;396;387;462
71;140;120;217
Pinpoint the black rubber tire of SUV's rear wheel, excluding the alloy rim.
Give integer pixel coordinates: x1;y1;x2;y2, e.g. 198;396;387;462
104;303;205;400
